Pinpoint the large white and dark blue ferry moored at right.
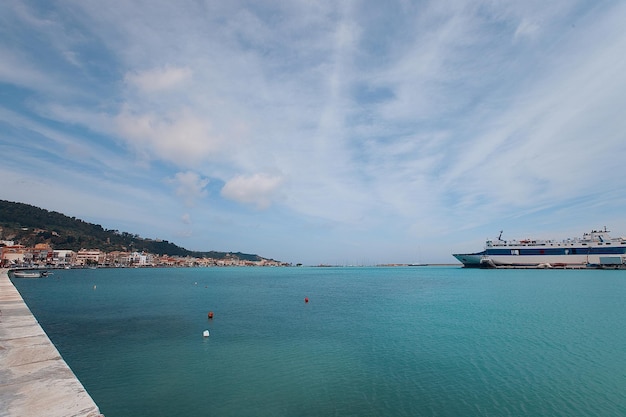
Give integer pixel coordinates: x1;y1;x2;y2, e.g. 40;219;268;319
452;227;626;268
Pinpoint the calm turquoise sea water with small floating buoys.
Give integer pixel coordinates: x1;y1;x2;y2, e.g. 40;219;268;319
13;267;626;417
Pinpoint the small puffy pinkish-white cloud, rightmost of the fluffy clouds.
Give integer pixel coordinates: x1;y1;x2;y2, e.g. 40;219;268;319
222;174;284;209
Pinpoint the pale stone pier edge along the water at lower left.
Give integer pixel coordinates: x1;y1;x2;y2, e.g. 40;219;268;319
0;269;102;417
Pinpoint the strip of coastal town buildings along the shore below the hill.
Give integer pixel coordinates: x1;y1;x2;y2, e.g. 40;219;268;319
0;240;290;268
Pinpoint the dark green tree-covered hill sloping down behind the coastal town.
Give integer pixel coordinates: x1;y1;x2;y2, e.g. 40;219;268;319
0;200;263;261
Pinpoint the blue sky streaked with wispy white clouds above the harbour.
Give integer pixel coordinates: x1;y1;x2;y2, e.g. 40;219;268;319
0;0;626;264
